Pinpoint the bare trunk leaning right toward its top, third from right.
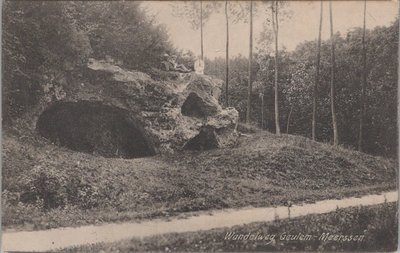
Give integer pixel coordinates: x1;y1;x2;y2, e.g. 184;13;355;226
311;0;323;141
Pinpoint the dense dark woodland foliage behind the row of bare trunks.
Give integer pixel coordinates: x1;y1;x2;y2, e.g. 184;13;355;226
205;20;399;157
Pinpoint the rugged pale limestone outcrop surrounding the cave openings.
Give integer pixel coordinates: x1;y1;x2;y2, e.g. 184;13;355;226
39;59;239;157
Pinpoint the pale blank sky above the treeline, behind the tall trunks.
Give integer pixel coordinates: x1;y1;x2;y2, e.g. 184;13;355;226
143;0;398;58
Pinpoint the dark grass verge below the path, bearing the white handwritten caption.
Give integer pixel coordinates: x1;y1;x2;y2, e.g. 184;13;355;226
64;203;398;252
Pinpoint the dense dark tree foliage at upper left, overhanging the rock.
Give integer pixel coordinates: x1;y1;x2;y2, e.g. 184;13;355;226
3;1;175;124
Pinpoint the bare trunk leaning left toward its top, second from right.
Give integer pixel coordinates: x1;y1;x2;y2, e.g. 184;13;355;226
329;0;339;146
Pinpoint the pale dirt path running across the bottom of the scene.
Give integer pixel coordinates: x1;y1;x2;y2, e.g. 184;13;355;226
2;191;398;251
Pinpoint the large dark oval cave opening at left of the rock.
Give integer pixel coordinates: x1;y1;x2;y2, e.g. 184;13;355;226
36;101;156;158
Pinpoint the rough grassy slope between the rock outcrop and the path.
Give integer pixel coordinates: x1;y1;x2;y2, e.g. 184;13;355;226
2;128;397;230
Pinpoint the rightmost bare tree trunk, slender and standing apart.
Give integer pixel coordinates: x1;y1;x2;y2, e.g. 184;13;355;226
358;0;367;151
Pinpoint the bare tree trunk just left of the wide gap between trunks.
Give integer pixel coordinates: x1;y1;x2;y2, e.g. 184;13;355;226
271;1;281;135
